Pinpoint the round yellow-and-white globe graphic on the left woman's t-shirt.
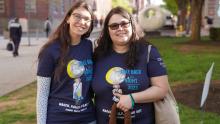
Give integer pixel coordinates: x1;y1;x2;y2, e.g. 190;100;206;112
67;59;85;78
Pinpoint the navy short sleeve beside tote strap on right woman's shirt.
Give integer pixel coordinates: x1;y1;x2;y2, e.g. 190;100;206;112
147;47;167;77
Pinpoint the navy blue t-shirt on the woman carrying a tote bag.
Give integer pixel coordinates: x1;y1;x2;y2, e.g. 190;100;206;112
92;45;167;124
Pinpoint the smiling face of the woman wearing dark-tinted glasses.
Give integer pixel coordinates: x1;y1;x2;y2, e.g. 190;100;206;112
108;14;132;46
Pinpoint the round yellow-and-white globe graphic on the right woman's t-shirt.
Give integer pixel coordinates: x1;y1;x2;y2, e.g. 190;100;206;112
105;67;126;85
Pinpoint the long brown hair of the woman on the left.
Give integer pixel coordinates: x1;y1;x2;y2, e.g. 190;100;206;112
38;1;94;79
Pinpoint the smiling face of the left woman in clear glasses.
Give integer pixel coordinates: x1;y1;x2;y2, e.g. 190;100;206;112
67;7;92;36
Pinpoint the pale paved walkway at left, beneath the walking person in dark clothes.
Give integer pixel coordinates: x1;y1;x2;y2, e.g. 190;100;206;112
0;36;46;96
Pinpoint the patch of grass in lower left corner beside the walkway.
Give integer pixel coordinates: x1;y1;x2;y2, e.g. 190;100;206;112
0;82;36;124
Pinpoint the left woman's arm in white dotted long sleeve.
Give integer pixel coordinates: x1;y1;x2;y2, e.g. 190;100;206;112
36;76;51;124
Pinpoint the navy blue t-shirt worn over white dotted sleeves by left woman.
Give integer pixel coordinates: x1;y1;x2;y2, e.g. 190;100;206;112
37;39;95;124
